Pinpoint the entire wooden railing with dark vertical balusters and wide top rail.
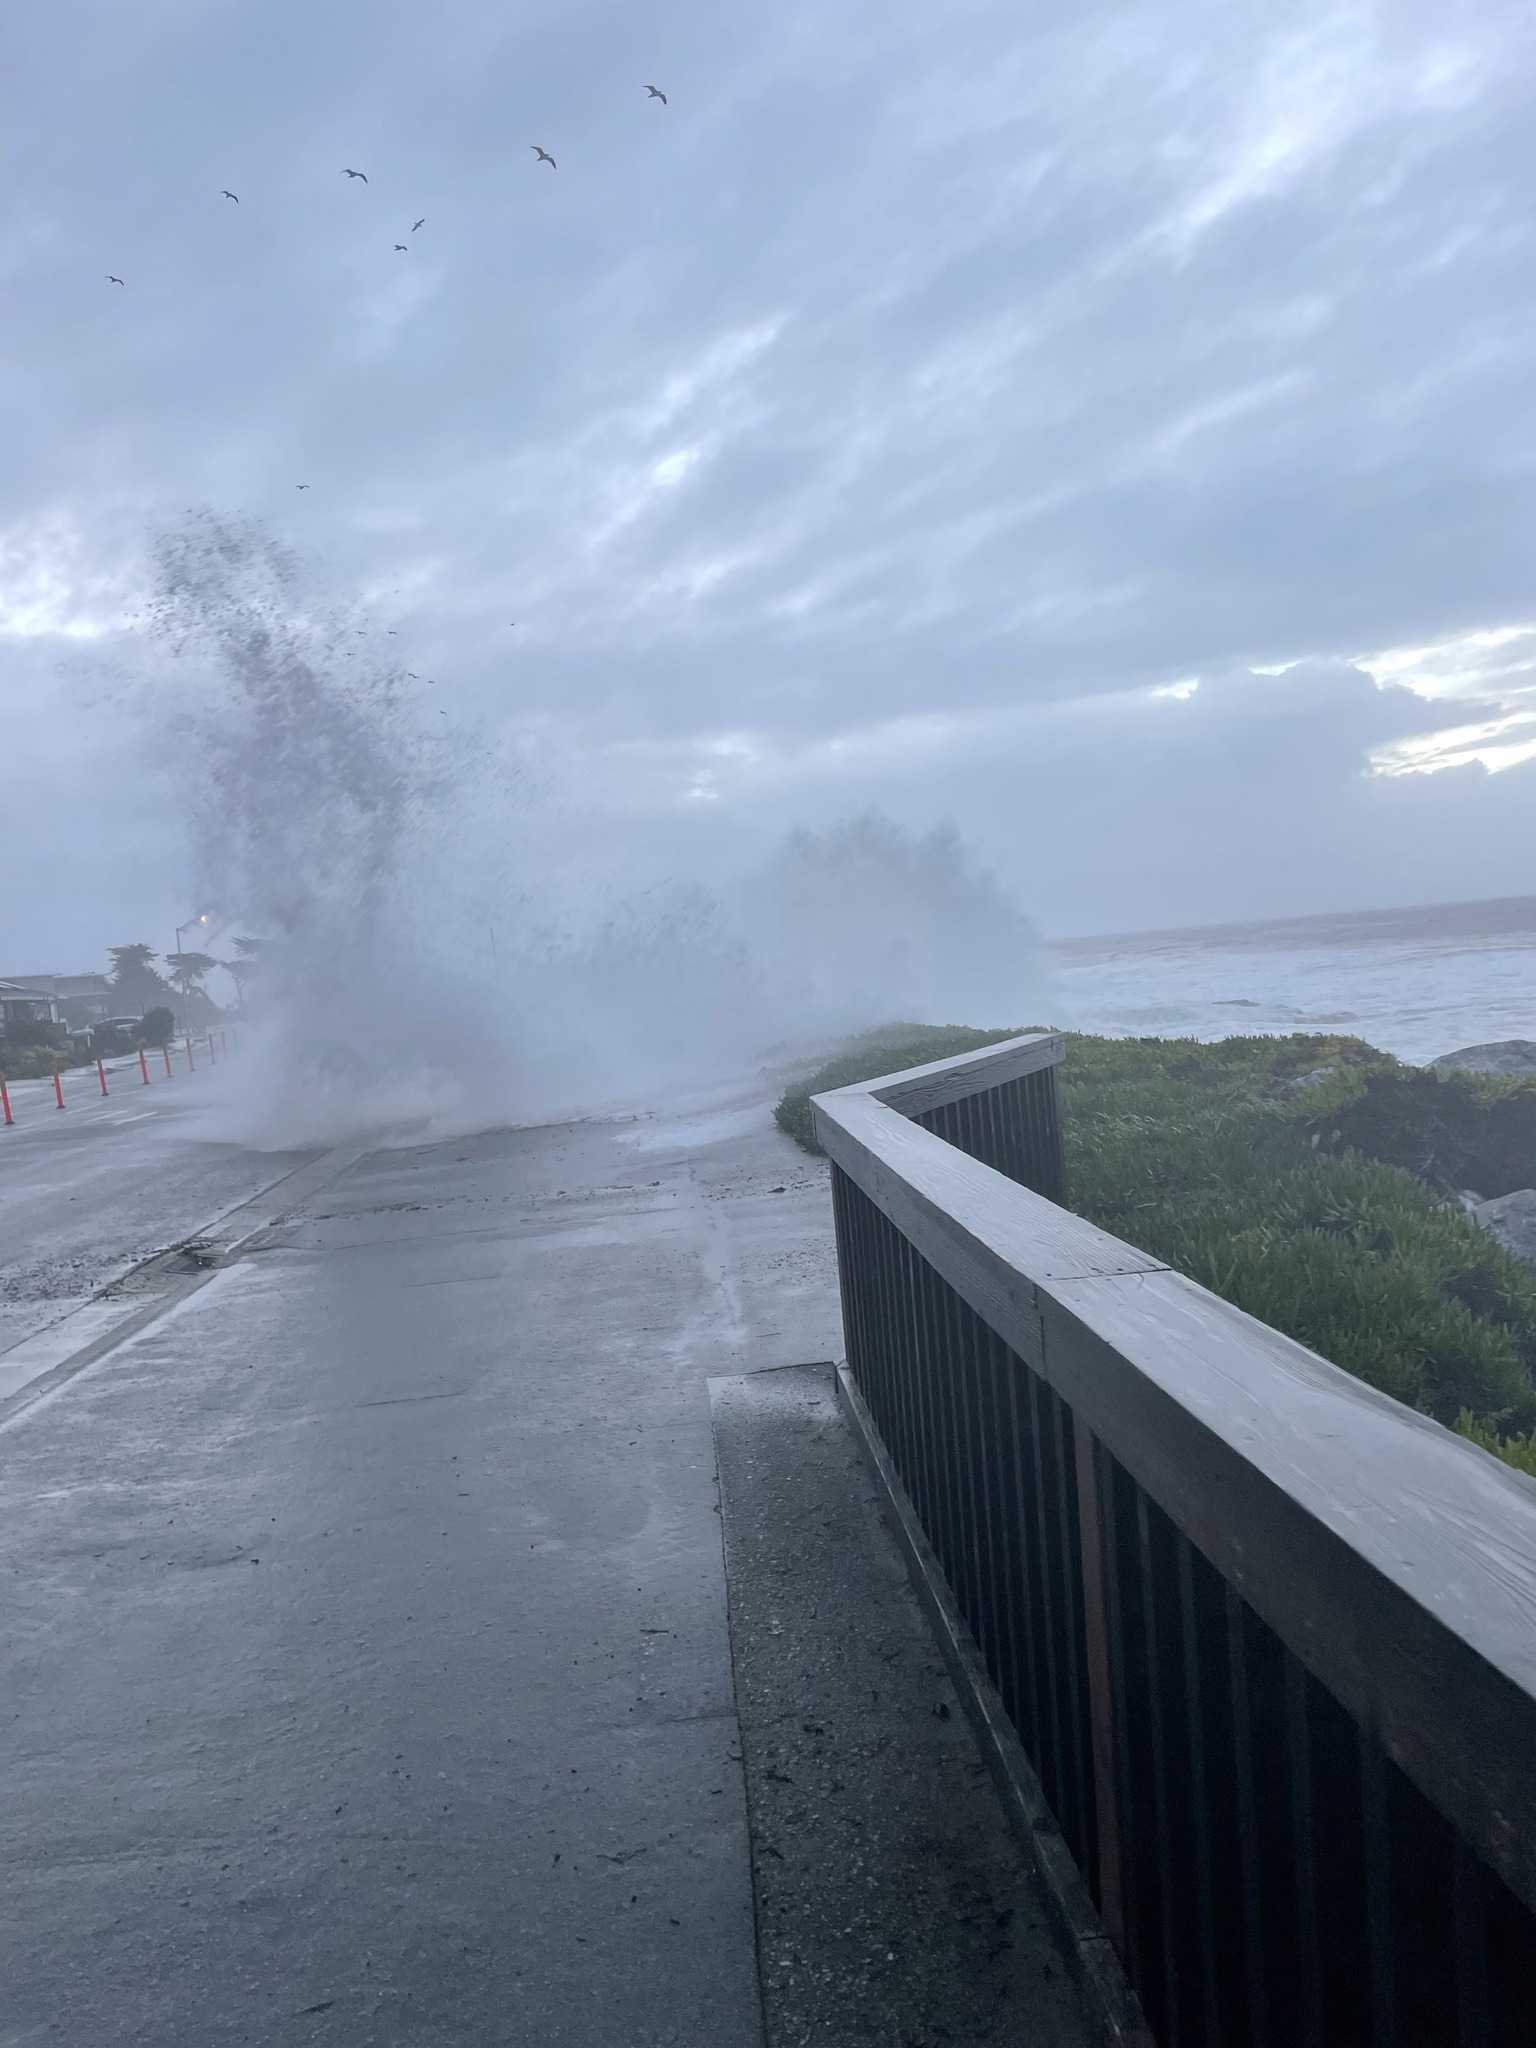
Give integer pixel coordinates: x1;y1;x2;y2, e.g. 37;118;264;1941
815;1034;1536;2048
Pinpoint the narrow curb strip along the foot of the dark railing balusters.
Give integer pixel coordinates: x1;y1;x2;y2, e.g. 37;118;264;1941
838;1364;1157;2048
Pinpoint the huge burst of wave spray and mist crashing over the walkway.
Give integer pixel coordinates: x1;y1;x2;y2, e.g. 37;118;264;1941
145;514;1044;1147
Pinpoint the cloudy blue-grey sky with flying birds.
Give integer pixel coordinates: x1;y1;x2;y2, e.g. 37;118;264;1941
0;0;1536;971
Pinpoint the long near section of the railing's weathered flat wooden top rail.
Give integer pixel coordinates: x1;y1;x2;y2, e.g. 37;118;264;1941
815;1055;1536;1907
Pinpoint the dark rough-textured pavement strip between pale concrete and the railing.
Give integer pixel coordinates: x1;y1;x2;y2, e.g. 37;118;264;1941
711;1366;1085;2048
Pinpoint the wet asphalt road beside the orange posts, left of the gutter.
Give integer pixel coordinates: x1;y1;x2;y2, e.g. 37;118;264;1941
0;1059;315;1356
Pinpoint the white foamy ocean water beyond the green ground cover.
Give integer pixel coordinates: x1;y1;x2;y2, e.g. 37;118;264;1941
1049;897;1536;1061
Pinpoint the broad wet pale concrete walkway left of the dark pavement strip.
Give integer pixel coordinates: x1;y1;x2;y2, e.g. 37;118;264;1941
0;1096;1097;2048
